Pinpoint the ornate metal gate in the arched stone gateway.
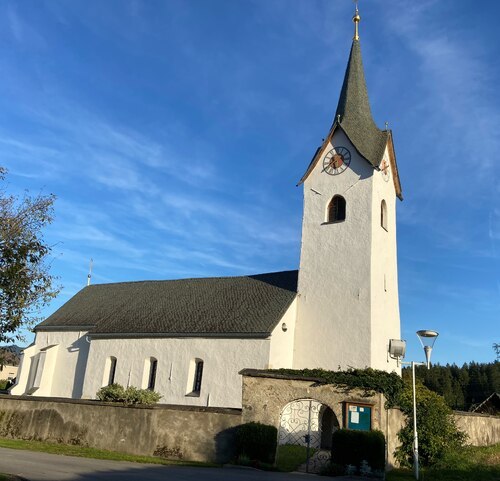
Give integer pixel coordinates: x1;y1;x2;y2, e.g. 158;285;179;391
278;399;335;473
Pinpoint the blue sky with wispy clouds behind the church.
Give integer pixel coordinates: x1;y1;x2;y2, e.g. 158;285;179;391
0;0;500;364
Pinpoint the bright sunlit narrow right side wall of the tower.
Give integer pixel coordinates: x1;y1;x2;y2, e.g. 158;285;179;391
371;149;401;372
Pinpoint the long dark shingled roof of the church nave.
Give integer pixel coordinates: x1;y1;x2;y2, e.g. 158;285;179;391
36;271;298;337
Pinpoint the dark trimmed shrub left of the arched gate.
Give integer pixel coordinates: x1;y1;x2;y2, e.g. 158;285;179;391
236;423;278;463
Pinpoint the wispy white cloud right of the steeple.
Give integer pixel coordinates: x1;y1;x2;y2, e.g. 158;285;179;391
386;0;500;182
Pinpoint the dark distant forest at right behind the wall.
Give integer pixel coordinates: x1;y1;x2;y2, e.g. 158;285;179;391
403;361;500;411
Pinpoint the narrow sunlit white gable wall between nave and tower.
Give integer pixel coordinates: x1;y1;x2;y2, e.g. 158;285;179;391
268;298;297;369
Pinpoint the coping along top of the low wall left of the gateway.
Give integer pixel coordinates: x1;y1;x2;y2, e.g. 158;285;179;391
0;394;242;416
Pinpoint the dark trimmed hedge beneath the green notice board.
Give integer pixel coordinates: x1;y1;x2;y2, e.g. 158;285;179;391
332;429;385;470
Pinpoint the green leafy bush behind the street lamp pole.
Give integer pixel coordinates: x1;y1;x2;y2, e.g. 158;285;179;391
395;381;466;467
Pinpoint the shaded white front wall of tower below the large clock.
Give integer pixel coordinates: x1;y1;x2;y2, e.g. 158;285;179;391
294;129;373;370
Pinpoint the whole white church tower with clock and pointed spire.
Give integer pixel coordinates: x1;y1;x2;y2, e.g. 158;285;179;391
293;8;402;371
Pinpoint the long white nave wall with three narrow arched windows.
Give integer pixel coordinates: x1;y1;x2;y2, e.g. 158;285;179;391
83;338;270;408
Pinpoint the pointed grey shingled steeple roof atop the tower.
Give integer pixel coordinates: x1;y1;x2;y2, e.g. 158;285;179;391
332;38;389;167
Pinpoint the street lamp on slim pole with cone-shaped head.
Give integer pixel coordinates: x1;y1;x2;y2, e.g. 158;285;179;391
389;329;439;480
